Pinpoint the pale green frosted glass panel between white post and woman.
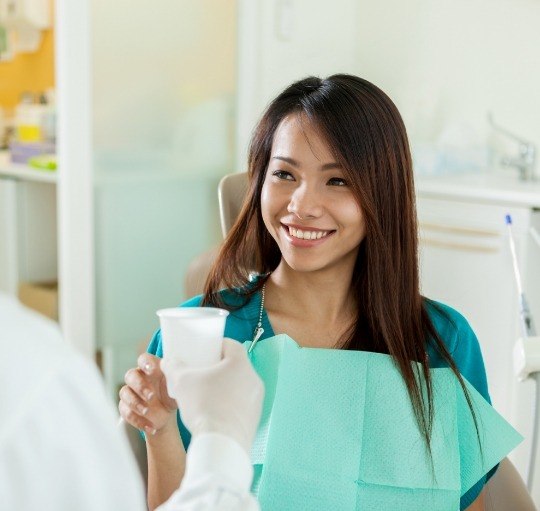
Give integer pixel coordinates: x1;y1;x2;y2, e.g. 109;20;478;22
91;0;236;395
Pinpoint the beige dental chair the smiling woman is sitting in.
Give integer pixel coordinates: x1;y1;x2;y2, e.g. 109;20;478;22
126;173;536;511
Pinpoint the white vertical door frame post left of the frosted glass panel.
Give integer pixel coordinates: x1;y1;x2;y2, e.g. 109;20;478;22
55;0;96;358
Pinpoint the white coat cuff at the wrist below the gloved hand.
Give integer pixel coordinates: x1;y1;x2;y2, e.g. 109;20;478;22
157;433;260;511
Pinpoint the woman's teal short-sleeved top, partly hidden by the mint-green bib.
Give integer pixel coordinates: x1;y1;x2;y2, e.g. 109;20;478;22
148;290;497;510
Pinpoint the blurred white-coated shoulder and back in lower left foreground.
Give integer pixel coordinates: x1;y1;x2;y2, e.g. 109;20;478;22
0;293;145;511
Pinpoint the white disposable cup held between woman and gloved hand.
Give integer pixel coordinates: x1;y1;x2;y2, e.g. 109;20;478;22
156;307;229;367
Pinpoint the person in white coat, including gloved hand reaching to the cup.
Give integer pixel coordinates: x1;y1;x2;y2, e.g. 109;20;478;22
0;293;262;511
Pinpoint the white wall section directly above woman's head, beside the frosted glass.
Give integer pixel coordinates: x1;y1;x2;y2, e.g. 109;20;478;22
235;0;361;170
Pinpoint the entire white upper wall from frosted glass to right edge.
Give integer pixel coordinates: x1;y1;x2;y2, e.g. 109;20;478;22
236;0;540;173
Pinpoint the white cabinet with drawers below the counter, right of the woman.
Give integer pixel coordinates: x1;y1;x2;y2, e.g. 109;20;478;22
418;195;540;492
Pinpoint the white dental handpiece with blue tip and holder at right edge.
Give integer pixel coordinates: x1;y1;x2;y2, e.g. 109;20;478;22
506;215;540;491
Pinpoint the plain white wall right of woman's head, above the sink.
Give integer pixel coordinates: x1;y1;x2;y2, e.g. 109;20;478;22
357;0;540;173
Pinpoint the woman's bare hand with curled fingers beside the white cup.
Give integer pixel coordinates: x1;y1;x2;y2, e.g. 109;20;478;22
118;353;177;435
